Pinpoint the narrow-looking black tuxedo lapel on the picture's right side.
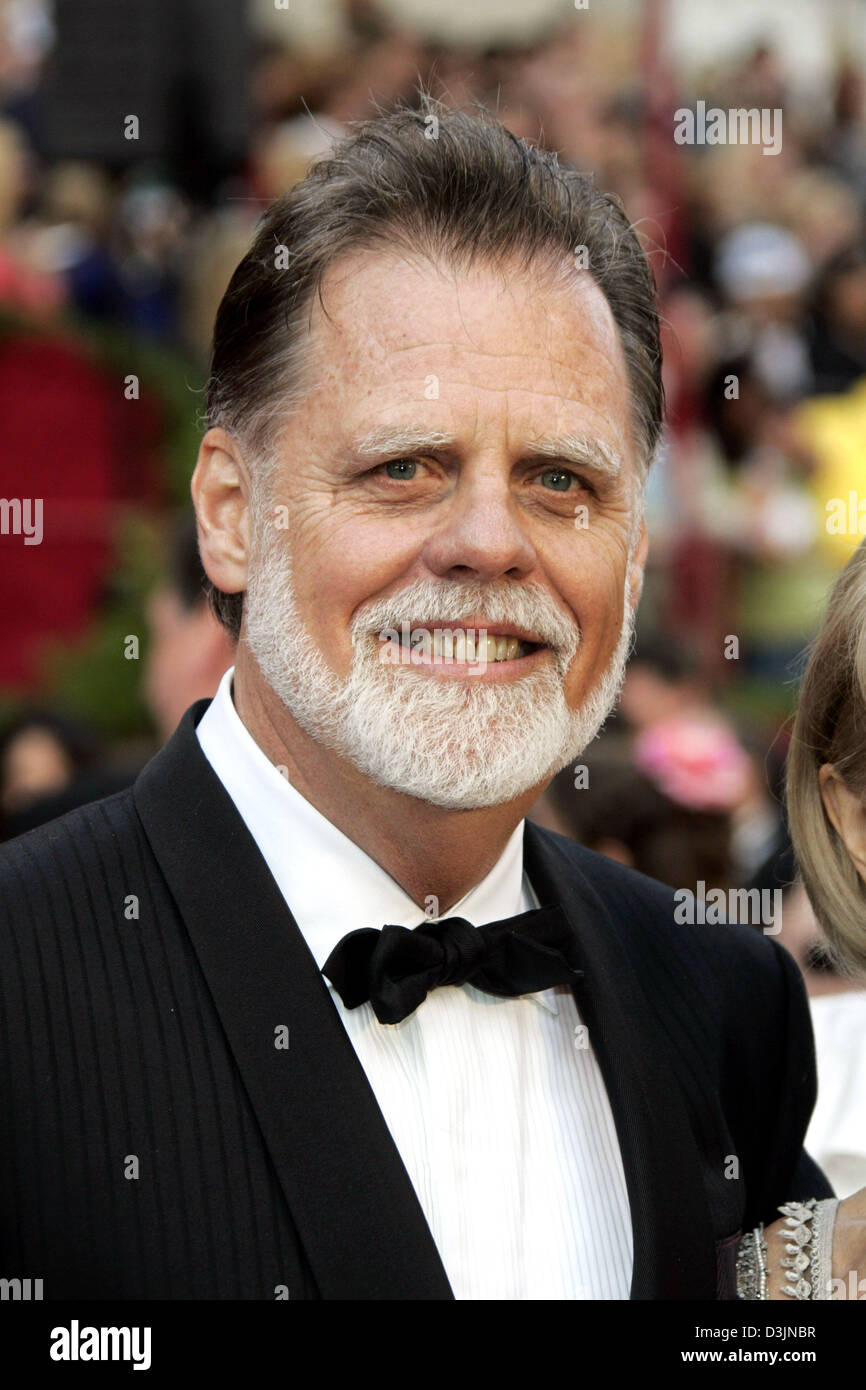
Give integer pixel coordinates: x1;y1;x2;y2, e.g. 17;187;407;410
524;821;716;1300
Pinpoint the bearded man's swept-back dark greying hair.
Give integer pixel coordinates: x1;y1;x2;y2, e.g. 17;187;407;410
207;93;663;637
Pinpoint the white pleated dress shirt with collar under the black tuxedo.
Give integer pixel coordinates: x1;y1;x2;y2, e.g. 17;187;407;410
197;667;632;1300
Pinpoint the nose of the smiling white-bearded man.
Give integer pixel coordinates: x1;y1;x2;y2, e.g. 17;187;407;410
423;473;537;582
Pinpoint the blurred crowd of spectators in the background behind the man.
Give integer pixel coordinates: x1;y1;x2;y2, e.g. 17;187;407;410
0;0;866;1184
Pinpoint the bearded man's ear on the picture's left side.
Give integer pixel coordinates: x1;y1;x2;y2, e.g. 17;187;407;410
190;427;252;594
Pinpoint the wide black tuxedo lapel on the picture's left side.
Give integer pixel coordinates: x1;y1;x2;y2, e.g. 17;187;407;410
135;701;453;1300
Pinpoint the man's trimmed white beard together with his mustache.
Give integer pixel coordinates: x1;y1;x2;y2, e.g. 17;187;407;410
243;507;634;810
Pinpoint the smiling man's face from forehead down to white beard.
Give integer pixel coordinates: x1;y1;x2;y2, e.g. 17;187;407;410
240;252;647;803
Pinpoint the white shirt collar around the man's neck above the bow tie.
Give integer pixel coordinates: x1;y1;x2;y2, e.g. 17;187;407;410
196;666;559;1013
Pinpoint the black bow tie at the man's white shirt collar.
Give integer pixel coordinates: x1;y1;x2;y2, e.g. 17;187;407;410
322;906;582;1023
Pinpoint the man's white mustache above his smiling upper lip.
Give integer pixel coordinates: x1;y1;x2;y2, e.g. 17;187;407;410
350;580;580;660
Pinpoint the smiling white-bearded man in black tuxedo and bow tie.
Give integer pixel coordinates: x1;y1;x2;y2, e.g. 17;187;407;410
0;106;828;1300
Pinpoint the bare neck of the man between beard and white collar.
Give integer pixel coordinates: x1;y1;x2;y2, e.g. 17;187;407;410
234;645;544;916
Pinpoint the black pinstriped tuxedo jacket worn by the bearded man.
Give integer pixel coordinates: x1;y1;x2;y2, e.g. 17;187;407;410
0;701;831;1300
